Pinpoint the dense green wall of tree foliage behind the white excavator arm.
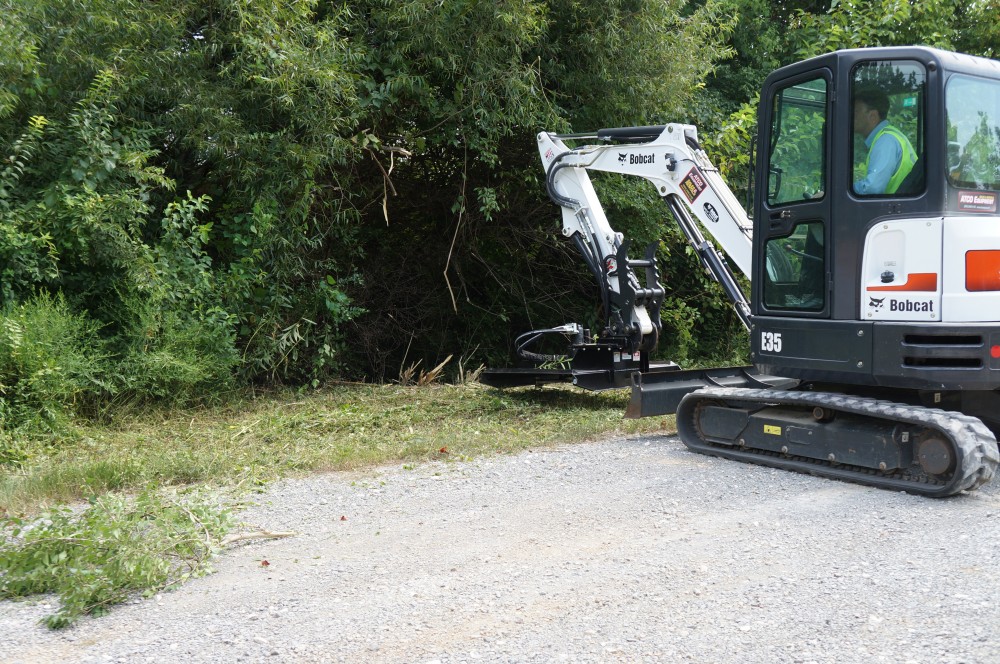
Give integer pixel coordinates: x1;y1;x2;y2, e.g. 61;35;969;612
0;0;997;436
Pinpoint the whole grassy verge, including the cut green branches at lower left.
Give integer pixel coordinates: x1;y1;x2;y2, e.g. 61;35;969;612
0;384;673;628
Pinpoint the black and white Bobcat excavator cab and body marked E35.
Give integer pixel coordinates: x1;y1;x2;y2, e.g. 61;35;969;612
750;47;1000;404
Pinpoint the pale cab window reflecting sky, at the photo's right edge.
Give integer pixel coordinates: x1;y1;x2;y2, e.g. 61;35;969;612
945;74;1000;189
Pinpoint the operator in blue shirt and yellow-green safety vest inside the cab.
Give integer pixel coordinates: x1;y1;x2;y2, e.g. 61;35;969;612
854;88;917;196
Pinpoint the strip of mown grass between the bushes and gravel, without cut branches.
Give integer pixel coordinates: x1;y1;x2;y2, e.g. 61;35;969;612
0;384;673;516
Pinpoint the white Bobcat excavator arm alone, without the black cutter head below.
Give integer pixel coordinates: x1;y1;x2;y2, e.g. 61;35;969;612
538;124;752;338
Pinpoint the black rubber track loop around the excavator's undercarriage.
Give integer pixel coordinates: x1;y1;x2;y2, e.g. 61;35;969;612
677;387;1000;498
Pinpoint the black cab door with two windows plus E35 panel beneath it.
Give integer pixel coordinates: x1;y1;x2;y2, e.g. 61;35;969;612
751;65;871;382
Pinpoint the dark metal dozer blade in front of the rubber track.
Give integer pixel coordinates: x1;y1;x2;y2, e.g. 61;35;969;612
625;366;799;419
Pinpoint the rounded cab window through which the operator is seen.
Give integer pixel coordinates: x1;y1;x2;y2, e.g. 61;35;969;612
851;60;927;196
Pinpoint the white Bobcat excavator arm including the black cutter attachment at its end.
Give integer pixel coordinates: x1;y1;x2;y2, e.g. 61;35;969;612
481;124;768;399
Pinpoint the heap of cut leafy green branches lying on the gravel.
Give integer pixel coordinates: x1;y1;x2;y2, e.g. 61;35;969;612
0;488;229;628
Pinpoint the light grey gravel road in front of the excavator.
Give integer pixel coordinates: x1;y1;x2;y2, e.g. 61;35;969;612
0;436;1000;664
